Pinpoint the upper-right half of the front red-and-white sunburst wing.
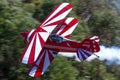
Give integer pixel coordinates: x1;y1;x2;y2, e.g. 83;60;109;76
38;3;72;33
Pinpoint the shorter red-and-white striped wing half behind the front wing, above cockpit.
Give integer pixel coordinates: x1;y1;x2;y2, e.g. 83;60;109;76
55;18;78;38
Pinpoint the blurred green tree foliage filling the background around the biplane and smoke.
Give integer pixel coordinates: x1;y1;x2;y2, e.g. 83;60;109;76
0;0;120;80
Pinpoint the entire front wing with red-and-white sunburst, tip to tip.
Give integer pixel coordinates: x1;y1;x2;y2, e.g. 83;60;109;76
21;3;72;64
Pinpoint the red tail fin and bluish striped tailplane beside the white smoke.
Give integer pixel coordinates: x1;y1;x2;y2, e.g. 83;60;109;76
77;36;100;61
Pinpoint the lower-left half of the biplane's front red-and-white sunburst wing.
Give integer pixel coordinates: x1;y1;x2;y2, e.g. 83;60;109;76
20;29;49;64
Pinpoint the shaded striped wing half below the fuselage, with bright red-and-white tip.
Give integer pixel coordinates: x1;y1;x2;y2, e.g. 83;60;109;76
29;49;57;77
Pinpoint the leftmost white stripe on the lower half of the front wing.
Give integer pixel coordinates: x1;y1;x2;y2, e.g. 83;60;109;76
22;35;35;64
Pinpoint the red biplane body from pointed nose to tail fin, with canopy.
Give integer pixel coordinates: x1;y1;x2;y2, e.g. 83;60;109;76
21;30;100;52
